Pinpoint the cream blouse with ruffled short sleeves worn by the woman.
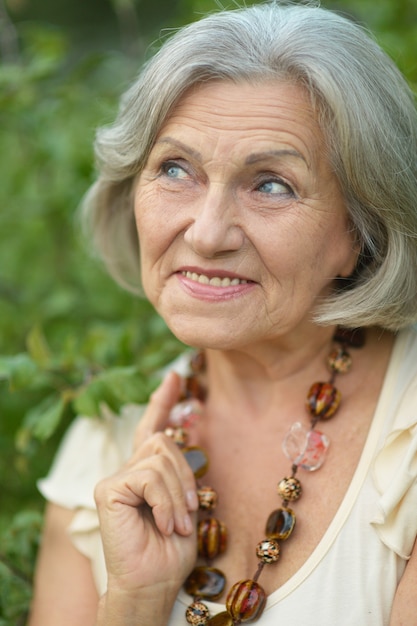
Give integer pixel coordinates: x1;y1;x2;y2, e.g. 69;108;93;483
39;328;417;626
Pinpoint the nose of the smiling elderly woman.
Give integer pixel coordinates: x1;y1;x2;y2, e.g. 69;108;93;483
184;185;245;258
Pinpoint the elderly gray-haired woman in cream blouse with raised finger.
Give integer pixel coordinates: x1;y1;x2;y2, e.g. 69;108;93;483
30;3;417;626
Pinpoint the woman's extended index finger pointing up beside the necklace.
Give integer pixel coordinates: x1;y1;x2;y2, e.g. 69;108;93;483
134;372;181;449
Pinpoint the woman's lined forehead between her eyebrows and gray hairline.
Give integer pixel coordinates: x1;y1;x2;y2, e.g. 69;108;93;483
158;81;324;161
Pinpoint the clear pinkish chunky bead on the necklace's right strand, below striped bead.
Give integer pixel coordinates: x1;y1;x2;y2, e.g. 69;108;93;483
282;422;330;472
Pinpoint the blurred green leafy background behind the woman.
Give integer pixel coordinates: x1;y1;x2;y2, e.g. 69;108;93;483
0;0;417;626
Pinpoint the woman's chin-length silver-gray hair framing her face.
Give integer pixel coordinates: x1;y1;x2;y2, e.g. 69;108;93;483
83;2;417;330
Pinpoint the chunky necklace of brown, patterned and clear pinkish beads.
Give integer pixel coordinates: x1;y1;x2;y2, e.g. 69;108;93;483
165;327;365;626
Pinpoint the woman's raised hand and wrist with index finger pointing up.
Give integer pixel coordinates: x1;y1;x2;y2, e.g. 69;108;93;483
95;373;198;624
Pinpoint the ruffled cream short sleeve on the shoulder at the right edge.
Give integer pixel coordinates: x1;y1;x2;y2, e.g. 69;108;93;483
372;378;417;559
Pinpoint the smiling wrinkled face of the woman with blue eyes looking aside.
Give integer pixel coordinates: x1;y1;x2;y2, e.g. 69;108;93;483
135;81;357;349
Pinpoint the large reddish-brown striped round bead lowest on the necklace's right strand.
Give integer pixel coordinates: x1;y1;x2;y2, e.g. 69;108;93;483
226;580;266;622
